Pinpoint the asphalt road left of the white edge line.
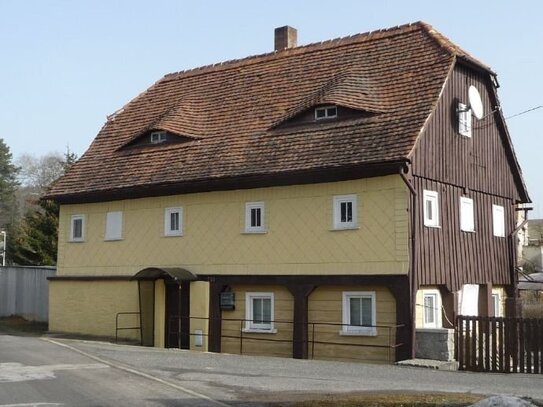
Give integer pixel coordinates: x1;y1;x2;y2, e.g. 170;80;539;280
0;335;225;407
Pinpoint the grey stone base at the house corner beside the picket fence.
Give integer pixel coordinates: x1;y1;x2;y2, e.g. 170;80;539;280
416;328;454;361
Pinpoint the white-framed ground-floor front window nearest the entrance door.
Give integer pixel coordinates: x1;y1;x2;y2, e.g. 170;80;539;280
245;292;277;333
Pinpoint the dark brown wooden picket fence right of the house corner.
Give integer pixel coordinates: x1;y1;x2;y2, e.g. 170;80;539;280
455;316;543;374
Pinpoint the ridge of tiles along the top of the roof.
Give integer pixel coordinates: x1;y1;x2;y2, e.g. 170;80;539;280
164;21;426;82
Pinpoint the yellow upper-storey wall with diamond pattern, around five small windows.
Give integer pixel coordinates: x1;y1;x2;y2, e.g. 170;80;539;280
58;175;408;276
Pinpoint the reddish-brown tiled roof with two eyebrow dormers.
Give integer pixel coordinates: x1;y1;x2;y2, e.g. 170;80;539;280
50;23;488;201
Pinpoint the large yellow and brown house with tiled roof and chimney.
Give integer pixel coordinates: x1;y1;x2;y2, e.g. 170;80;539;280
49;22;529;362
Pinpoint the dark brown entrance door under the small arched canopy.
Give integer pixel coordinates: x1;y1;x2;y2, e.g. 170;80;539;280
165;281;190;349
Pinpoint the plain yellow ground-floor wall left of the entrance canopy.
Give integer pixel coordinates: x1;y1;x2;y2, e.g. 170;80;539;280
49;281;140;341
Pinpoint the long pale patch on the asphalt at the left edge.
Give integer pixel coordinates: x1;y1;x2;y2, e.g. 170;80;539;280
0;363;109;383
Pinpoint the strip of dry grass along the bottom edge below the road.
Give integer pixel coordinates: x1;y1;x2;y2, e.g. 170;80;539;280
285;392;484;407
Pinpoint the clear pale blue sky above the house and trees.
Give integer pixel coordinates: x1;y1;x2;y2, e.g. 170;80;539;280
0;0;543;218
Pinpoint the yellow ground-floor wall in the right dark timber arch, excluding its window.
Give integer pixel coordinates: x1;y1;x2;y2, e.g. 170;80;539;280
308;286;396;363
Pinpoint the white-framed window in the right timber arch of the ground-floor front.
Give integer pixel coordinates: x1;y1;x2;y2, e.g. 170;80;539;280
340;291;377;336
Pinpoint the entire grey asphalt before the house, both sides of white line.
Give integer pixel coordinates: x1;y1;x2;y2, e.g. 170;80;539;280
0;336;543;406
